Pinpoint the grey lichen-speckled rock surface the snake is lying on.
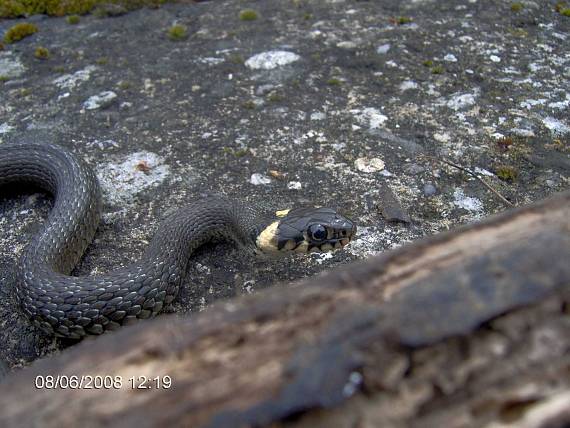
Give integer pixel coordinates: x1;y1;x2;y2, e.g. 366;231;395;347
0;0;570;367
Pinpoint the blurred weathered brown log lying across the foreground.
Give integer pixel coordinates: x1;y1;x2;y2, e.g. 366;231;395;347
0;192;570;427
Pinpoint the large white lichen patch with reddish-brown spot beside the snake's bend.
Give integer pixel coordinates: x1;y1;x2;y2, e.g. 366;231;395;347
97;151;170;206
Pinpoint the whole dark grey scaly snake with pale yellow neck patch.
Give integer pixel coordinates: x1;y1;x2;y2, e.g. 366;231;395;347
0;142;356;339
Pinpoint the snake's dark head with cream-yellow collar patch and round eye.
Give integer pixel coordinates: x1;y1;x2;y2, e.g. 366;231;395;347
257;207;356;253
